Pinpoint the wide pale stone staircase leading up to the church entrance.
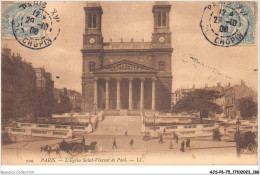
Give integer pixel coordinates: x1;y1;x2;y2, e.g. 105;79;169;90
90;116;141;135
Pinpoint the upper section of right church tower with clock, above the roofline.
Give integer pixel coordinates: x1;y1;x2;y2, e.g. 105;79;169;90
152;2;171;48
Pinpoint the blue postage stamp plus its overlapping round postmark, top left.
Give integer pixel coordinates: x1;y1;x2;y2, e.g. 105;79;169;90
2;2;60;50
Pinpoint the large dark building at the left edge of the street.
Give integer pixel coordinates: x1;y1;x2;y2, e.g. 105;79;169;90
1;48;36;121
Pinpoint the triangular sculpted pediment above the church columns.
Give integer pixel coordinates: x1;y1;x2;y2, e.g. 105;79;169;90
94;60;156;73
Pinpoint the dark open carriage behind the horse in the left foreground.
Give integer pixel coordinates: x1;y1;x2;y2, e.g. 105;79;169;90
59;140;98;156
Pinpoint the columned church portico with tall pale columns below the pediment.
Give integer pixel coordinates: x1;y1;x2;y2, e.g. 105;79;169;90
94;76;156;110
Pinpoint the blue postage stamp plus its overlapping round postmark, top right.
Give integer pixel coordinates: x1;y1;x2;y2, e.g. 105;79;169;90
200;2;255;47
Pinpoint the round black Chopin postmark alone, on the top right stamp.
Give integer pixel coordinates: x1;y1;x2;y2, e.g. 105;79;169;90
200;2;249;47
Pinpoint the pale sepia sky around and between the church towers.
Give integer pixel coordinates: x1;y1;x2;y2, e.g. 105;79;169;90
1;1;258;92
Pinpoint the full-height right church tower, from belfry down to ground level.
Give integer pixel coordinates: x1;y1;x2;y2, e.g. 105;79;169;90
151;1;173;110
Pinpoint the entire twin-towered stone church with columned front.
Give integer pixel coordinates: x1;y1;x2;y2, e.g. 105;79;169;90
81;2;173;112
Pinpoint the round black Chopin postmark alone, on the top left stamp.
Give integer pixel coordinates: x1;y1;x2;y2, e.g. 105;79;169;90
12;3;60;50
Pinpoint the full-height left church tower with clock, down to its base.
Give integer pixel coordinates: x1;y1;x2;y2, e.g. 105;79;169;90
81;2;103;111
